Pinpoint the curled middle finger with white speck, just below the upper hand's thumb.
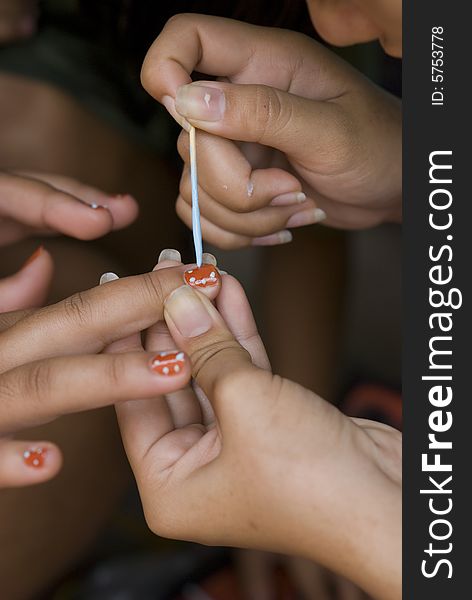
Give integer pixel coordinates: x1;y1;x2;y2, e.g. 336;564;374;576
177;131;302;213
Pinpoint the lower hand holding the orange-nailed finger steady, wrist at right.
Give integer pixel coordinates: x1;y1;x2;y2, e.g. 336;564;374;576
117;269;401;600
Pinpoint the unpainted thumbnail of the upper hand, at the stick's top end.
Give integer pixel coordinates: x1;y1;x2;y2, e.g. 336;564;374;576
175;83;225;121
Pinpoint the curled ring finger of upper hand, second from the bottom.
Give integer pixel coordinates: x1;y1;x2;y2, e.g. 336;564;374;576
180;164;325;237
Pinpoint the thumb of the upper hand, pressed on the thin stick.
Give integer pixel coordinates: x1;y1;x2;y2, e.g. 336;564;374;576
175;81;346;166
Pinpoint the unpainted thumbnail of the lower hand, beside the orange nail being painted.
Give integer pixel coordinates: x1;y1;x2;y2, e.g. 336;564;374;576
164;285;212;338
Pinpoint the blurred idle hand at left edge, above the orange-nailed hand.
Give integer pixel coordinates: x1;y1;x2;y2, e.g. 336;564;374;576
0;171;138;246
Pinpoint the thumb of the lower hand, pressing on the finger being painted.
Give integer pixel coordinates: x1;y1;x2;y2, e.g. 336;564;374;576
164;285;260;416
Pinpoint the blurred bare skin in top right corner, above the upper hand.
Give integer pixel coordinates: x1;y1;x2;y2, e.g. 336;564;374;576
307;0;402;58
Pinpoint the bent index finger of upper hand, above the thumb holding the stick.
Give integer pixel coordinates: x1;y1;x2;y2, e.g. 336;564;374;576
141;14;346;103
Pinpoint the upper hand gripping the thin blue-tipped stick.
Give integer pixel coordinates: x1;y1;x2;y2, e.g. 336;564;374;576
142;14;401;248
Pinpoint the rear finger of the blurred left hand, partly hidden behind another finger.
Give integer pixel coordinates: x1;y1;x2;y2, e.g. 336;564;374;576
17;171;139;229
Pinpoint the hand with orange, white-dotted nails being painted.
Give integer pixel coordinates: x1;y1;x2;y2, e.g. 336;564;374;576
0;267;220;488
